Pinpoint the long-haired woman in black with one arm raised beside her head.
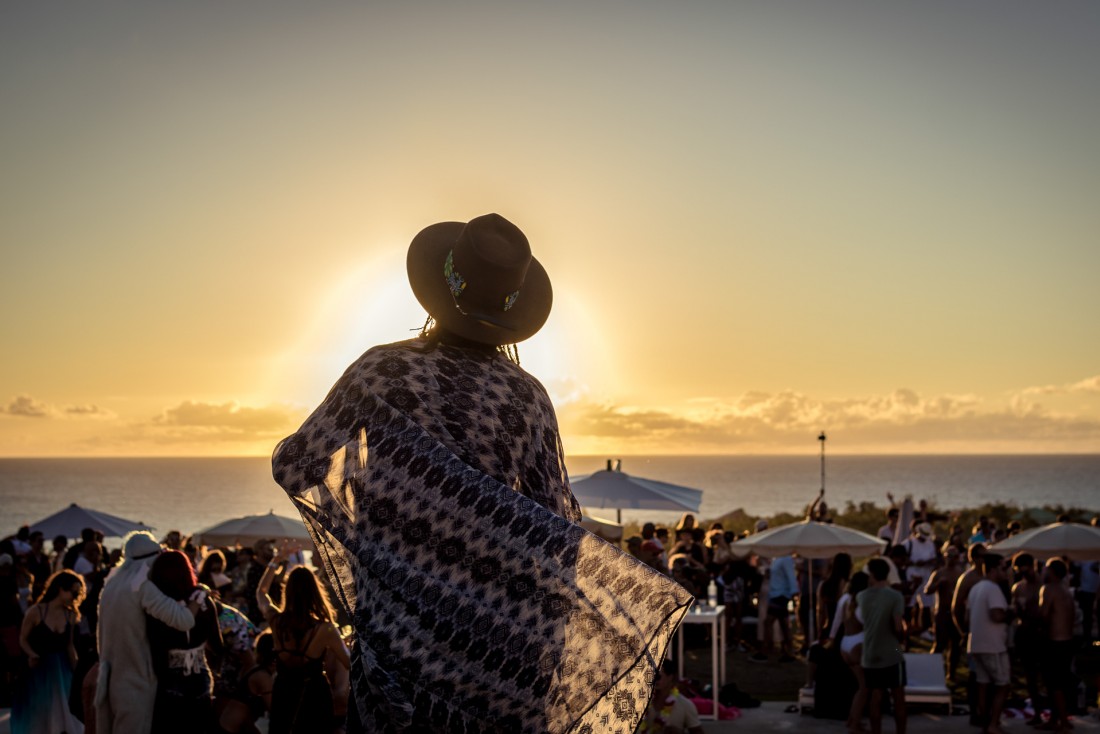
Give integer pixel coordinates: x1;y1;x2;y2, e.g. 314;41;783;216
256;546;350;734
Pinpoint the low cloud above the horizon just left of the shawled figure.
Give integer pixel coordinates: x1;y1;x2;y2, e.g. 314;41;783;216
143;401;304;442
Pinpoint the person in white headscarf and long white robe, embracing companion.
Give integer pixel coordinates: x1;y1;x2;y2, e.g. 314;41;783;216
96;530;198;734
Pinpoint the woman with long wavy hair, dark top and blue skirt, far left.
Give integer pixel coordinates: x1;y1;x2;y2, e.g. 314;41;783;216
11;570;84;734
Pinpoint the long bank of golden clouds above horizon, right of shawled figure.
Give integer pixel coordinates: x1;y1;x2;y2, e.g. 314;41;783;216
559;388;1100;453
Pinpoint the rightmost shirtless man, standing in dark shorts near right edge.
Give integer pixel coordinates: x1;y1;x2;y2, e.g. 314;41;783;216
1040;558;1075;732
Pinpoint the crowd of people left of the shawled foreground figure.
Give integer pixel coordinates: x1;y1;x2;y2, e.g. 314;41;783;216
0;527;350;734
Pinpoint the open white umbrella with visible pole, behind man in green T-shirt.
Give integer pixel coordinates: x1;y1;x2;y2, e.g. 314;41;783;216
733;519;886;644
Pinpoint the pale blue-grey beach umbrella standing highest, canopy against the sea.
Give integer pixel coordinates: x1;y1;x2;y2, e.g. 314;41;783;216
570;460;703;523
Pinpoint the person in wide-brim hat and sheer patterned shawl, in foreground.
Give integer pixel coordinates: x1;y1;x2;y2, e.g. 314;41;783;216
272;213;691;734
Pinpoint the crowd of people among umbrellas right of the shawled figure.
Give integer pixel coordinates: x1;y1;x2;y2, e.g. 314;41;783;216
626;506;1100;734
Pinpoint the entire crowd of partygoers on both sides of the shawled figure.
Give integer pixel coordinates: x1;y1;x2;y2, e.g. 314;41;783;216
0;508;1100;734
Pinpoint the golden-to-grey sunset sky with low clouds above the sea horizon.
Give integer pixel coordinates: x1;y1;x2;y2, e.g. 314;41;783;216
0;0;1100;456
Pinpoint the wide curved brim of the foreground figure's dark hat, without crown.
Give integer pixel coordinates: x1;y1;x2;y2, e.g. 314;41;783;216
406;221;553;347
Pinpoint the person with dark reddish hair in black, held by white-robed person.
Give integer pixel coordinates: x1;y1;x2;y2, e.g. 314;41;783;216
146;550;222;733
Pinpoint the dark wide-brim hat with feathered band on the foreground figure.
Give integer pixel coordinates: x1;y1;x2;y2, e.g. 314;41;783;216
406;213;553;347
